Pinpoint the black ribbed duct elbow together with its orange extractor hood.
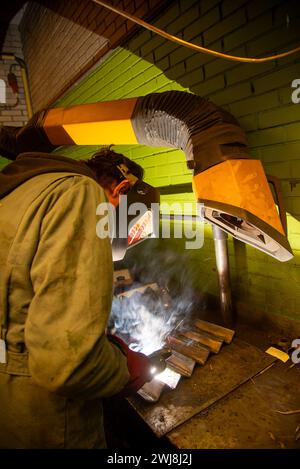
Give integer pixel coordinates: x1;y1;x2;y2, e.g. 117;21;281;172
132;91;293;261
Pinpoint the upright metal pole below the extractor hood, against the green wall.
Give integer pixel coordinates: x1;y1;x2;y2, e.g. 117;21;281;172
212;225;233;326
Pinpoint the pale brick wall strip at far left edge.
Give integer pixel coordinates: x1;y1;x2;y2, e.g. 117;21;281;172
0;24;28;133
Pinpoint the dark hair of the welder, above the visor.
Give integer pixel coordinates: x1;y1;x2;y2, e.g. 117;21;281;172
85;146;144;188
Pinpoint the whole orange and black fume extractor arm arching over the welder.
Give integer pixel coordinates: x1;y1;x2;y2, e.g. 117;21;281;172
1;91;293;261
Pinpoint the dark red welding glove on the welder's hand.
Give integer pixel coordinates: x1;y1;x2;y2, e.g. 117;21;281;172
107;334;153;396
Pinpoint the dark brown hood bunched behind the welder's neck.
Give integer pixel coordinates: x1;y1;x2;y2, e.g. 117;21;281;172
0;152;96;199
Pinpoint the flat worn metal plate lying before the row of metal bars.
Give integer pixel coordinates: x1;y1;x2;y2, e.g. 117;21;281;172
128;339;276;437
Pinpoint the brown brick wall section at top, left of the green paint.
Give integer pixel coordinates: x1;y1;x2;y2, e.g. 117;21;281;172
20;0;166;111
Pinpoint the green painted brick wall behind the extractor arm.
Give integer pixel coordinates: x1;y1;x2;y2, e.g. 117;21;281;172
0;0;300;320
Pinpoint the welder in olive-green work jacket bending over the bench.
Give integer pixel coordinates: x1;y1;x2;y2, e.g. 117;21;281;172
0;122;156;448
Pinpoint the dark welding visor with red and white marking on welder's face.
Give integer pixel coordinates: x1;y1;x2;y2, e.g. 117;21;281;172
112;180;160;261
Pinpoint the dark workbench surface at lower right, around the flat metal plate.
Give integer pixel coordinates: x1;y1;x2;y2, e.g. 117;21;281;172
103;325;300;449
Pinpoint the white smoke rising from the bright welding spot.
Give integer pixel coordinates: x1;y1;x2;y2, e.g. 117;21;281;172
110;241;210;355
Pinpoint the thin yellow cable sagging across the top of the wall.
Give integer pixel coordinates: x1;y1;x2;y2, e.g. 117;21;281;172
92;0;300;63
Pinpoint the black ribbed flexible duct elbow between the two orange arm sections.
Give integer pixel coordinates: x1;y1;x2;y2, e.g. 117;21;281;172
131;91;248;173
